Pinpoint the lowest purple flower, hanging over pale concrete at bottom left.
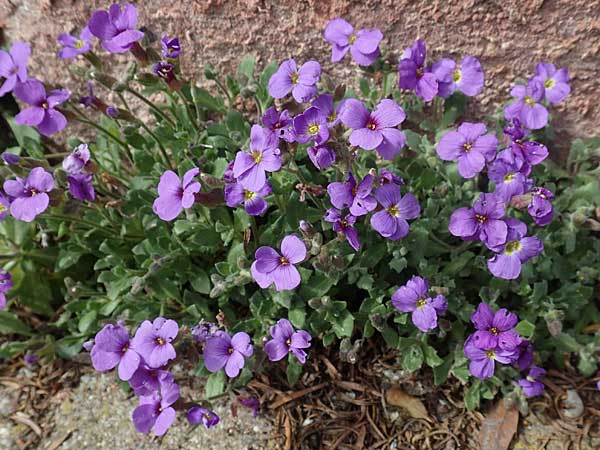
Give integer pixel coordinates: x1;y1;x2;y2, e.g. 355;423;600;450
131;372;179;436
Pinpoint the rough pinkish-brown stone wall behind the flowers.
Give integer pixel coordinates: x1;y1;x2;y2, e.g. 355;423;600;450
0;0;600;155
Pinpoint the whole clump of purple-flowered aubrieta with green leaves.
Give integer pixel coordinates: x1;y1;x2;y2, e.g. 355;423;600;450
0;0;600;435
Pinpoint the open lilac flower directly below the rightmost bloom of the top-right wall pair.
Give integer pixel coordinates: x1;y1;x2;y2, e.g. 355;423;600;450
436;122;498;178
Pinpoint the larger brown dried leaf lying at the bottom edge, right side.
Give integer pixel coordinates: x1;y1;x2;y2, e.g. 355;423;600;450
479;400;519;450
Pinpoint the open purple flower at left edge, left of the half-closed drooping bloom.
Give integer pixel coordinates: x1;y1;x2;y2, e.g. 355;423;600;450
4;167;54;222
